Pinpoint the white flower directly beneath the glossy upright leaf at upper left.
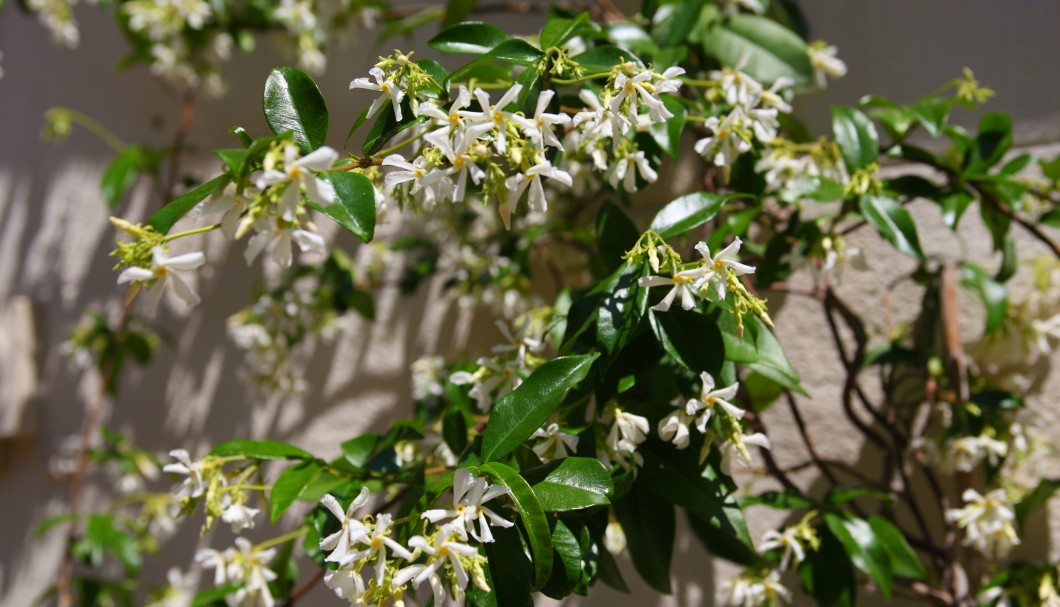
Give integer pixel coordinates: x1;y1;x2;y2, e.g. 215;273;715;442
255;143;338;221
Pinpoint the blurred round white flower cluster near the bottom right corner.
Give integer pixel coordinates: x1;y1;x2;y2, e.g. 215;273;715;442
946;488;1020;559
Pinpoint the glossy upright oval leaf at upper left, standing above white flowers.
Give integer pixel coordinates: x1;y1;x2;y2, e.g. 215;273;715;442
262;68;328;154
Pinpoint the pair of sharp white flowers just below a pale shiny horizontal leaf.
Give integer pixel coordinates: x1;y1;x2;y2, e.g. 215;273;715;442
637;238;755;311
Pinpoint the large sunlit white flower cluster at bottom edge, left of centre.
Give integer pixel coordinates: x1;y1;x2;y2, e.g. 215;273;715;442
320;468;514;605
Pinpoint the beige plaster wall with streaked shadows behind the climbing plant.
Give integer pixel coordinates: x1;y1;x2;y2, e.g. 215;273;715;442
0;0;1060;607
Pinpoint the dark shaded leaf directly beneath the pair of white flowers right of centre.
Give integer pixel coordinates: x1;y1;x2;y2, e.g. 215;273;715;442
648;306;725;376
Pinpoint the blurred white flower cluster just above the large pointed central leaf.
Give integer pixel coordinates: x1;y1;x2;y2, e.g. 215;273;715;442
449;314;545;413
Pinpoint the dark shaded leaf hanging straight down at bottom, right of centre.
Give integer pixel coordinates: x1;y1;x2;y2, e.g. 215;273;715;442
615;474;675;594
